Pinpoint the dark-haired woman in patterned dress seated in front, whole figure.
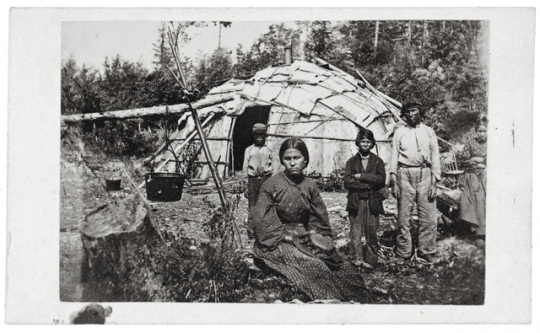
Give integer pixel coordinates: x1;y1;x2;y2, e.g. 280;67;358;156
253;138;371;303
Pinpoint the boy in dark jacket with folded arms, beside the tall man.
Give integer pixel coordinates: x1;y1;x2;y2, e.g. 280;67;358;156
343;128;386;267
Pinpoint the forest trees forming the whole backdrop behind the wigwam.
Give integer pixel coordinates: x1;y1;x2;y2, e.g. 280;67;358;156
61;21;489;150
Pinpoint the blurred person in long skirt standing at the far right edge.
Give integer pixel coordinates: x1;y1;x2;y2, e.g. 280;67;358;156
458;117;487;238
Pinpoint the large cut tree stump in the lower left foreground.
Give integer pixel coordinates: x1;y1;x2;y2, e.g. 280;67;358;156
79;195;162;302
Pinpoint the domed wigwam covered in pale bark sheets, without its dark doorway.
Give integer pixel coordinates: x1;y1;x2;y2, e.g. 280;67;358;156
151;59;401;179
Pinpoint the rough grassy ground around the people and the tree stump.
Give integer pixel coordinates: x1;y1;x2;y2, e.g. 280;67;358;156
60;145;485;305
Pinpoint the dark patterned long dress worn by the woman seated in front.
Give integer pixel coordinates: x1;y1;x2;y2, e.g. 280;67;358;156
253;172;371;303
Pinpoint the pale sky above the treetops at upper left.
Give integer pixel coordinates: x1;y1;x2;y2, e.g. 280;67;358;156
62;21;296;69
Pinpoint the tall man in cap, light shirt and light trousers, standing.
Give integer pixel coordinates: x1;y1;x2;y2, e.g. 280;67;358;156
390;100;441;263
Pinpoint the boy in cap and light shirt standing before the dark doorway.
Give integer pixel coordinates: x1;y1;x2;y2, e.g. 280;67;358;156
242;124;272;238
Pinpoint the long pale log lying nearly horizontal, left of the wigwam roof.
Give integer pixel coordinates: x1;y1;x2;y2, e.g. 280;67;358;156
61;95;234;124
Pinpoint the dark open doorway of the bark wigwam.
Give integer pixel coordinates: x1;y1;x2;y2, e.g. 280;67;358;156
233;105;270;171
